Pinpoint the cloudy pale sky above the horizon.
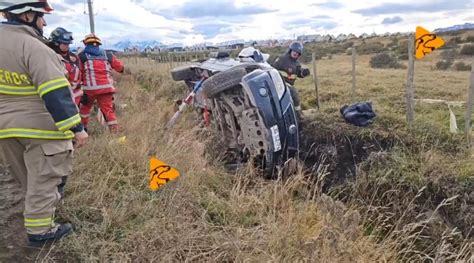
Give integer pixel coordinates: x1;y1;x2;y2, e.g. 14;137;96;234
33;0;474;46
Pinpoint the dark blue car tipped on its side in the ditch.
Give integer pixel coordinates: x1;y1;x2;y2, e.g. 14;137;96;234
171;52;299;178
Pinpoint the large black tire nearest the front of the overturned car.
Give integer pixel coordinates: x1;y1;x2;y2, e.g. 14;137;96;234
202;67;247;98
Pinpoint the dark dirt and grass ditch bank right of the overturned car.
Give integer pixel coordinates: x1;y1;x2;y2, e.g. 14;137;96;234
301;118;474;260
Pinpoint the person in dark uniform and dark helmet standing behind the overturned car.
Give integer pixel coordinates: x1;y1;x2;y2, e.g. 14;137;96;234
272;41;310;117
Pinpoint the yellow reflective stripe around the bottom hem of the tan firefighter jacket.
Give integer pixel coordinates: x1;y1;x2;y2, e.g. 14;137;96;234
0;128;74;140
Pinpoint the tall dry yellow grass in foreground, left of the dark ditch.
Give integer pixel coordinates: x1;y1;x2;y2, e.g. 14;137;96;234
38;59;395;262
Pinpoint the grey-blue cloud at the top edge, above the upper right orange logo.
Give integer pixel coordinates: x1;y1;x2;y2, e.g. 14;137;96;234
352;1;470;16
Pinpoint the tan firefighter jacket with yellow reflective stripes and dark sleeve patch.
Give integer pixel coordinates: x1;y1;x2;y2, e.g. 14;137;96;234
0;23;82;139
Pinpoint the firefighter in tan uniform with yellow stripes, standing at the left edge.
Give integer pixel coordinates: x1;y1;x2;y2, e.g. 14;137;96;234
0;0;87;246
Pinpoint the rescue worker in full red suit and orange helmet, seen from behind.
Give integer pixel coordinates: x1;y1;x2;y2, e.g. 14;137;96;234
79;34;124;132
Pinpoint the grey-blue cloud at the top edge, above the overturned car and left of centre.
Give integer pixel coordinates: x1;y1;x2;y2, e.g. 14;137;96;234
172;1;276;18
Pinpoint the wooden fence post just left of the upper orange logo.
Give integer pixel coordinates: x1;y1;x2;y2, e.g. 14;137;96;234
406;34;415;127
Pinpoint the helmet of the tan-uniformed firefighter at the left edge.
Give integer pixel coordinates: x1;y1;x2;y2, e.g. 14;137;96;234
0;0;53;15
